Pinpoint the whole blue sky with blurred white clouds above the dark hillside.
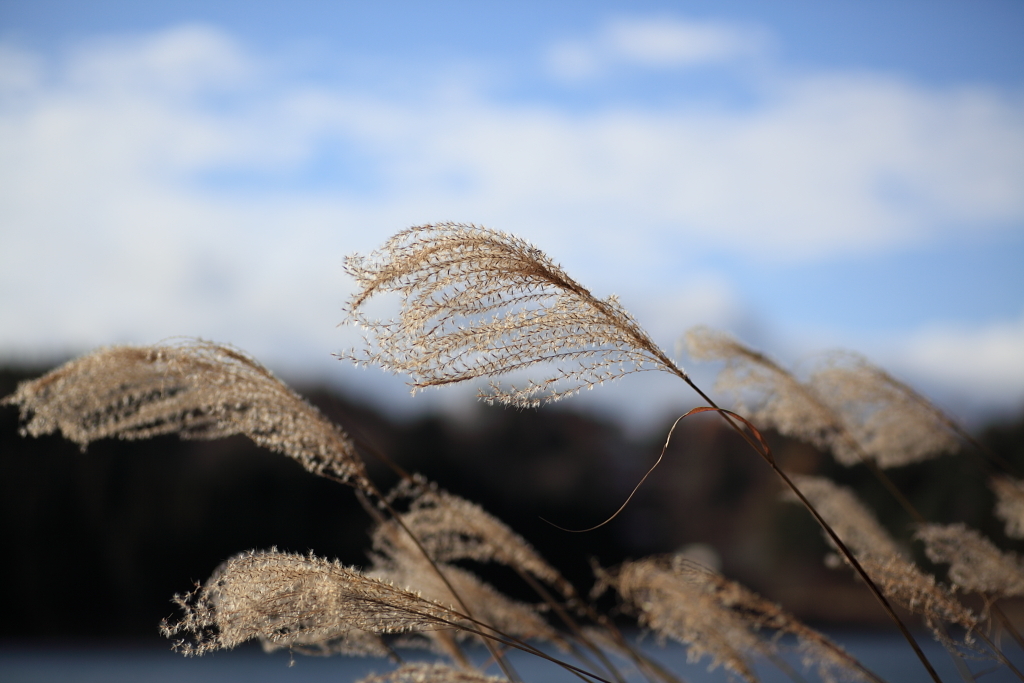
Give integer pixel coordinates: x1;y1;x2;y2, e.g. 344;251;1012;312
0;1;1024;428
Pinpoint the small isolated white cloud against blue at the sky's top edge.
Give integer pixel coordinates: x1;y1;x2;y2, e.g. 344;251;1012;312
548;17;768;79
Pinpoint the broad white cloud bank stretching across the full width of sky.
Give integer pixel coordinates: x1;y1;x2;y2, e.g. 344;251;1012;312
0;23;1024;417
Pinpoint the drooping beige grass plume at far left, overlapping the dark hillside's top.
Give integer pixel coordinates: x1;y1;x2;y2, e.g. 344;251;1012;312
3;340;367;485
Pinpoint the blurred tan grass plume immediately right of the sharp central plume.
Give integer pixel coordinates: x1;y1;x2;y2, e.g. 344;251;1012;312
686;327;863;465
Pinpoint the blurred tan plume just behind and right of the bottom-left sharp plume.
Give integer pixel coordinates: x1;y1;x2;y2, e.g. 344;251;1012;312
368;520;560;645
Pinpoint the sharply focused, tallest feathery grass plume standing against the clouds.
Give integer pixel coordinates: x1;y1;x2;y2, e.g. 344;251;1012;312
345;223;686;407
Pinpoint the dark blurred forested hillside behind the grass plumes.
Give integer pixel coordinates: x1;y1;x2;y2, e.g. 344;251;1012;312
0;369;1024;639
